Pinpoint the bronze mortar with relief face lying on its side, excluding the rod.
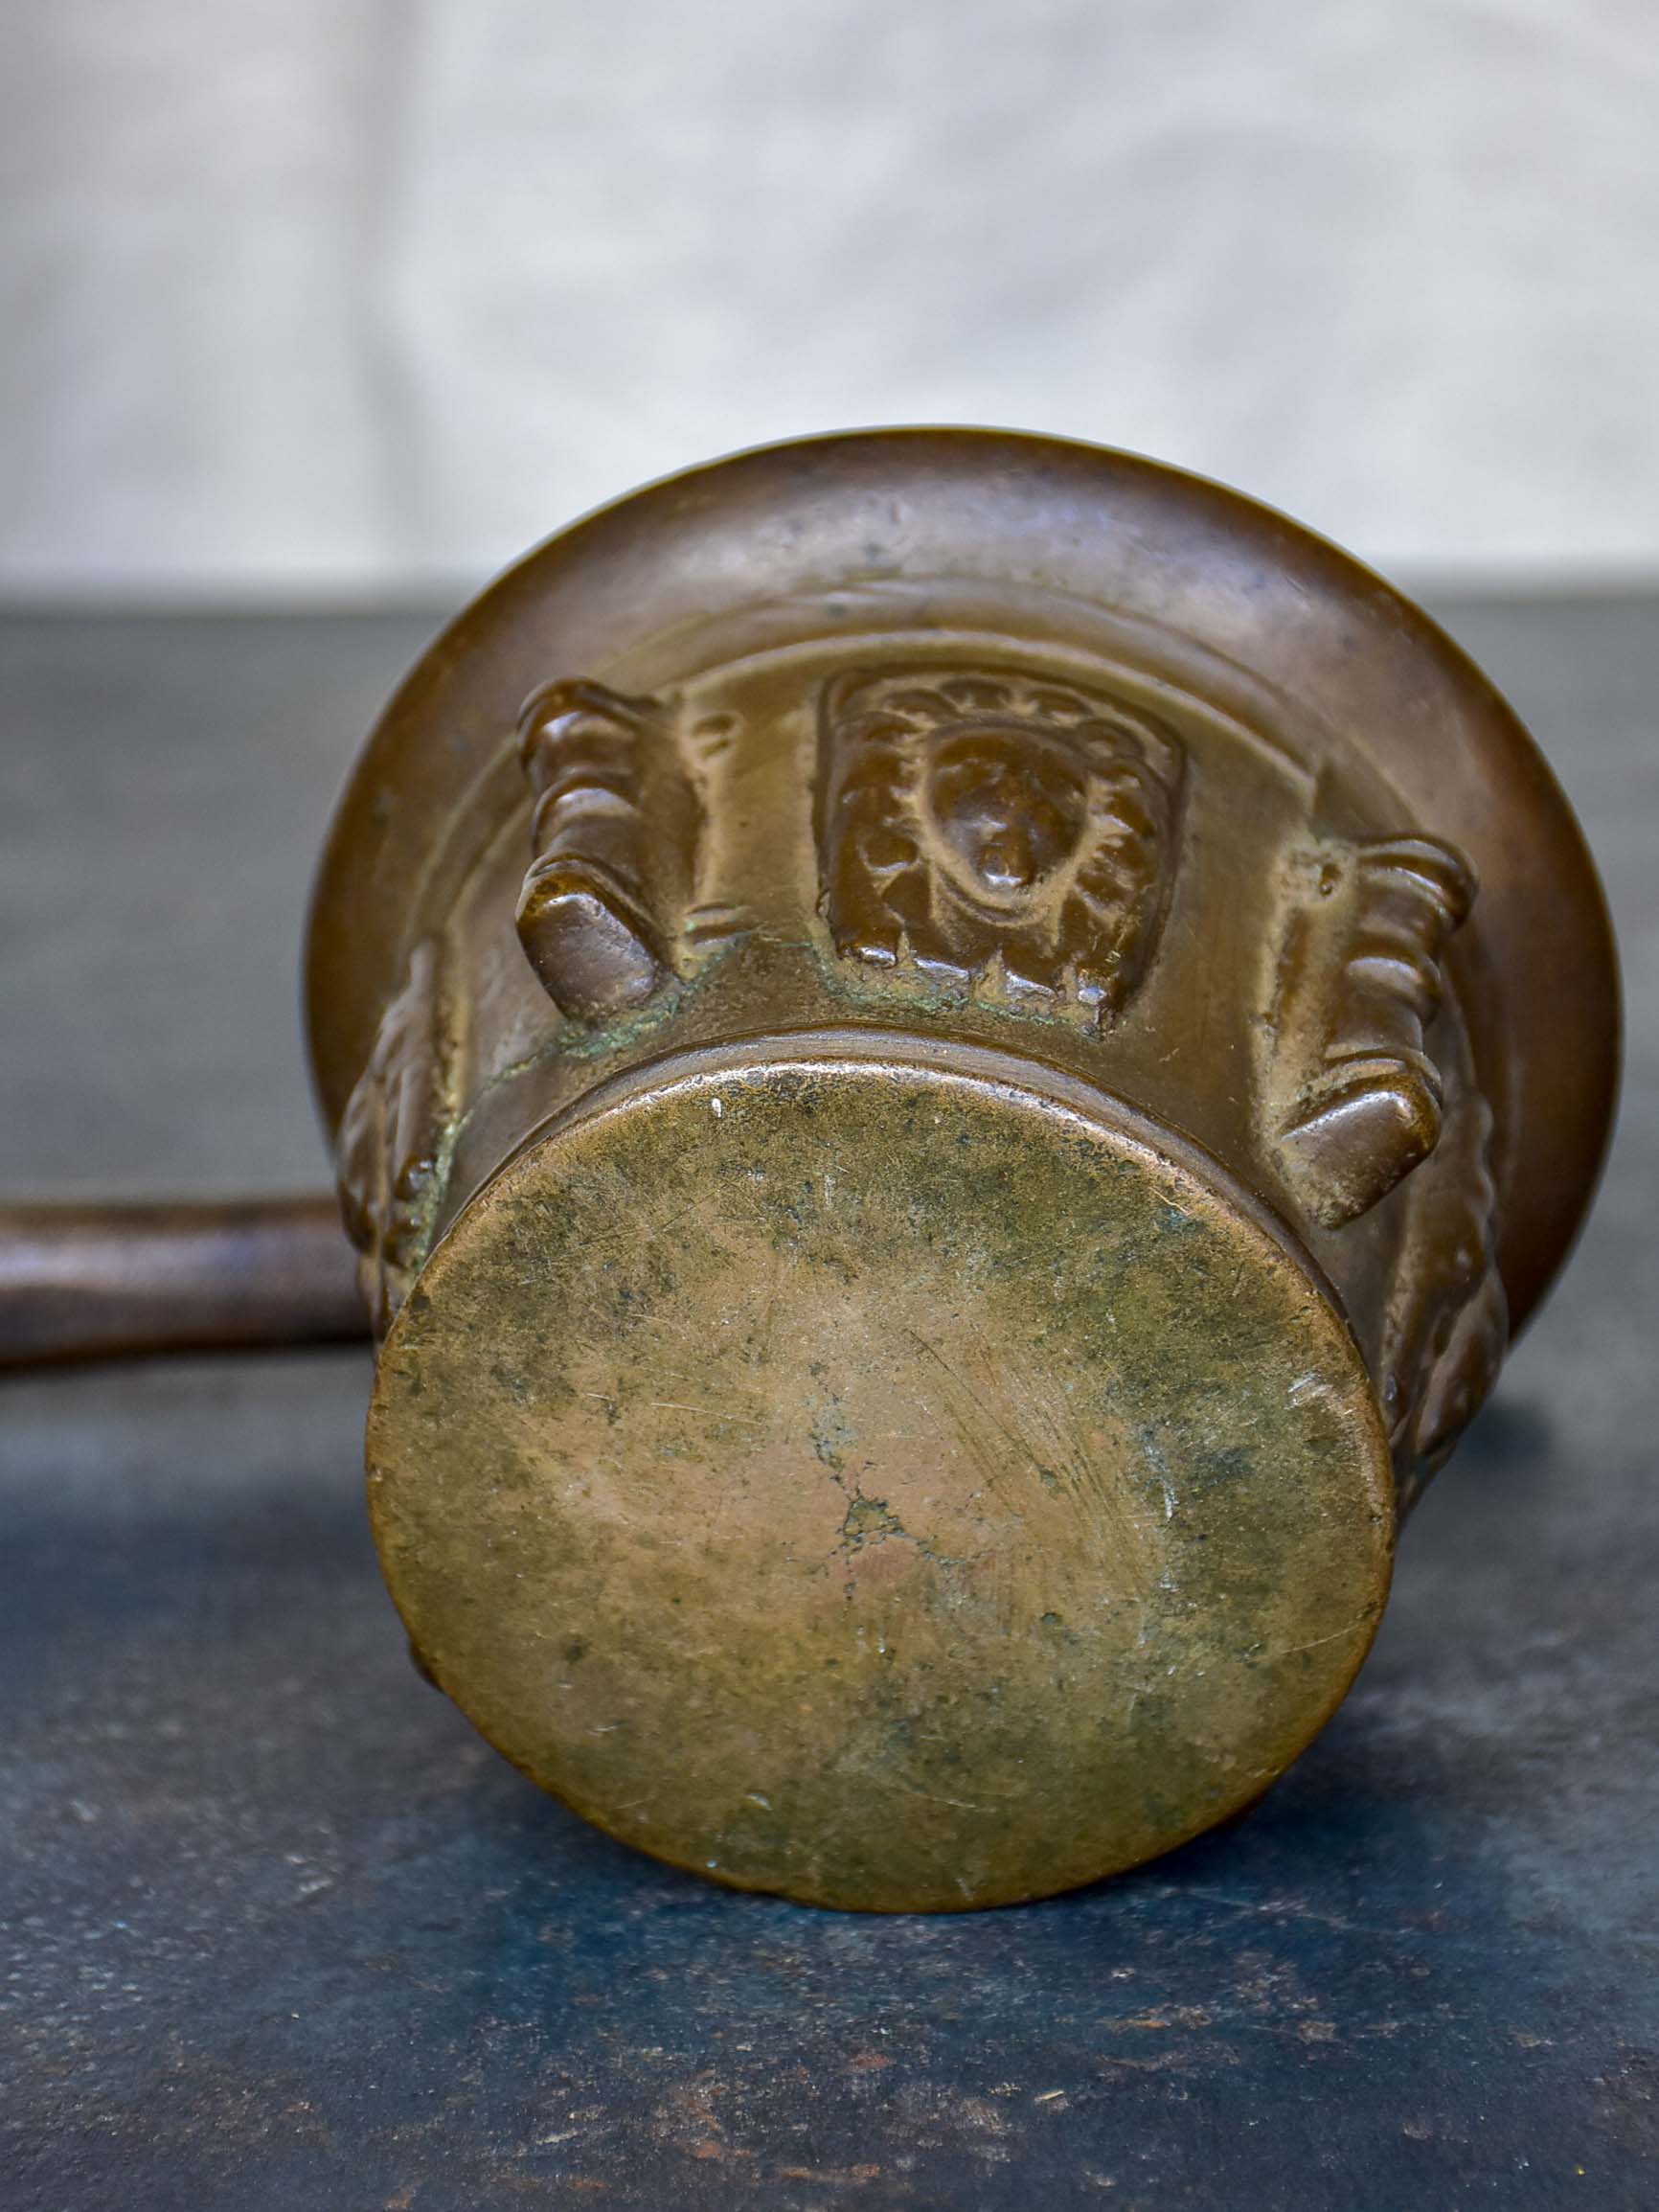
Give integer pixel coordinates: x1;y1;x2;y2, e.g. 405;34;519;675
309;431;1617;1909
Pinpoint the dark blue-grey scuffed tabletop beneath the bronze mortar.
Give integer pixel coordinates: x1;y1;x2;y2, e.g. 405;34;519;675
0;597;1659;2212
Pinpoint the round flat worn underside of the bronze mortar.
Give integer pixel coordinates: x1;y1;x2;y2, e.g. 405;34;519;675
370;1038;1394;1911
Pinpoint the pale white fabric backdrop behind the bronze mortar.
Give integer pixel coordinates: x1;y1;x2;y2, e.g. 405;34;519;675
0;0;1659;595
